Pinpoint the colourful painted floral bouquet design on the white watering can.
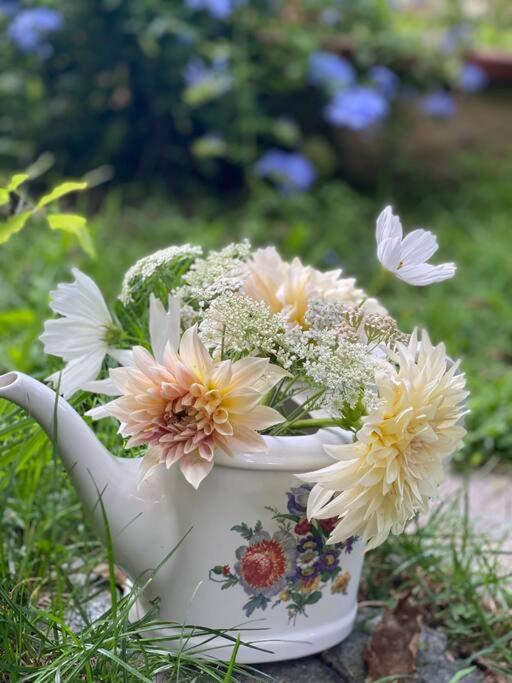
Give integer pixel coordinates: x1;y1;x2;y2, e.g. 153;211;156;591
209;484;355;621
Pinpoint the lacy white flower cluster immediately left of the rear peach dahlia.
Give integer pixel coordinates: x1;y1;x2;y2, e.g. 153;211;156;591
176;240;251;308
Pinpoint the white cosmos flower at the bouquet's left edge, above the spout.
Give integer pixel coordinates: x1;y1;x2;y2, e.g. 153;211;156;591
39;268;129;398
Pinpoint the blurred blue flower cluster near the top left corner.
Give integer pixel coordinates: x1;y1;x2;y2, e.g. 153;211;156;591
8;7;64;53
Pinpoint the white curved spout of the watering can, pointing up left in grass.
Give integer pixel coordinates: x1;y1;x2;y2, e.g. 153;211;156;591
0;372;180;592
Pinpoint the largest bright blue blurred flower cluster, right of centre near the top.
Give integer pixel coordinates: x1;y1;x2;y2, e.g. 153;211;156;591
325;85;389;130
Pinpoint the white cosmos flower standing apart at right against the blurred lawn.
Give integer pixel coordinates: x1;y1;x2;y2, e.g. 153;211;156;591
376;206;456;286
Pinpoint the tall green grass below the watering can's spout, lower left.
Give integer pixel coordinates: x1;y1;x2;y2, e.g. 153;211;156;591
0;402;258;683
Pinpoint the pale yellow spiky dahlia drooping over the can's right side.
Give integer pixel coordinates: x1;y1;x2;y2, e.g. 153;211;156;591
300;333;468;549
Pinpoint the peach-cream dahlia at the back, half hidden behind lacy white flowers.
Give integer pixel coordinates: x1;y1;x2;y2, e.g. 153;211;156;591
244;247;385;327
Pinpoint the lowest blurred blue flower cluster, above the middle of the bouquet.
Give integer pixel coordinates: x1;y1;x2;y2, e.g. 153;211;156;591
254;149;316;192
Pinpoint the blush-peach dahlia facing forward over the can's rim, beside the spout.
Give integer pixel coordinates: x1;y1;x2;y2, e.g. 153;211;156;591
96;327;283;488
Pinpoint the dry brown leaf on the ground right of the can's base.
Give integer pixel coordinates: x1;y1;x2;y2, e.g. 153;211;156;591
364;596;422;681
